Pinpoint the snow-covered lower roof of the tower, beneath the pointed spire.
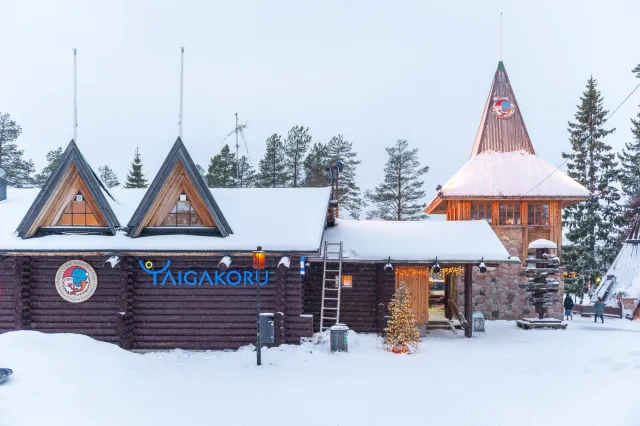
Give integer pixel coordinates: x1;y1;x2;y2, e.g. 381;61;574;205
440;151;589;198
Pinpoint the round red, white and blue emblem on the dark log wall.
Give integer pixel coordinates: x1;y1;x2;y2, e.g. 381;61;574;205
56;260;98;303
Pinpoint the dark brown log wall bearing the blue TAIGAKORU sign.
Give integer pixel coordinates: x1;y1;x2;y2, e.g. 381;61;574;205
0;254;313;350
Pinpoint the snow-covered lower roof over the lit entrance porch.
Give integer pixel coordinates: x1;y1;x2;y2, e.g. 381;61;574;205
323;219;520;263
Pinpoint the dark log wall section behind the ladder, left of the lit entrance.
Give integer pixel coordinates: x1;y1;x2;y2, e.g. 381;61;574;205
303;263;395;332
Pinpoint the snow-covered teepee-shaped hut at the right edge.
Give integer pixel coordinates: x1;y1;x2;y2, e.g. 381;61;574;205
594;211;640;319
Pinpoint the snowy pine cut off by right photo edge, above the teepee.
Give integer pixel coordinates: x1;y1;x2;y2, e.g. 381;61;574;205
618;65;640;223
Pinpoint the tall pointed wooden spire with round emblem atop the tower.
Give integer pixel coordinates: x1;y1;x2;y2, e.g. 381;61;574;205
471;61;535;157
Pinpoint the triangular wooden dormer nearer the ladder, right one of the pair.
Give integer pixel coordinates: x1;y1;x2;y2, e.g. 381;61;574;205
129;138;233;238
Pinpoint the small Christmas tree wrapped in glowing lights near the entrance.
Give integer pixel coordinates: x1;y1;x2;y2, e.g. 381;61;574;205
384;281;420;353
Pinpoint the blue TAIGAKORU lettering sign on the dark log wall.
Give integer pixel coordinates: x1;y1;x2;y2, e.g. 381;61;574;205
139;260;269;287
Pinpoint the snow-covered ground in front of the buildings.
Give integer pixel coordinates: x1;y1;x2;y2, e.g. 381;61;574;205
0;317;640;426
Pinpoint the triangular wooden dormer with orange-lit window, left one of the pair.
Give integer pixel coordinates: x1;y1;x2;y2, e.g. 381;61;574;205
16;140;120;238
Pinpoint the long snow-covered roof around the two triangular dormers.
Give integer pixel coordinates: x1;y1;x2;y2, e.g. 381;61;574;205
0;187;331;252
